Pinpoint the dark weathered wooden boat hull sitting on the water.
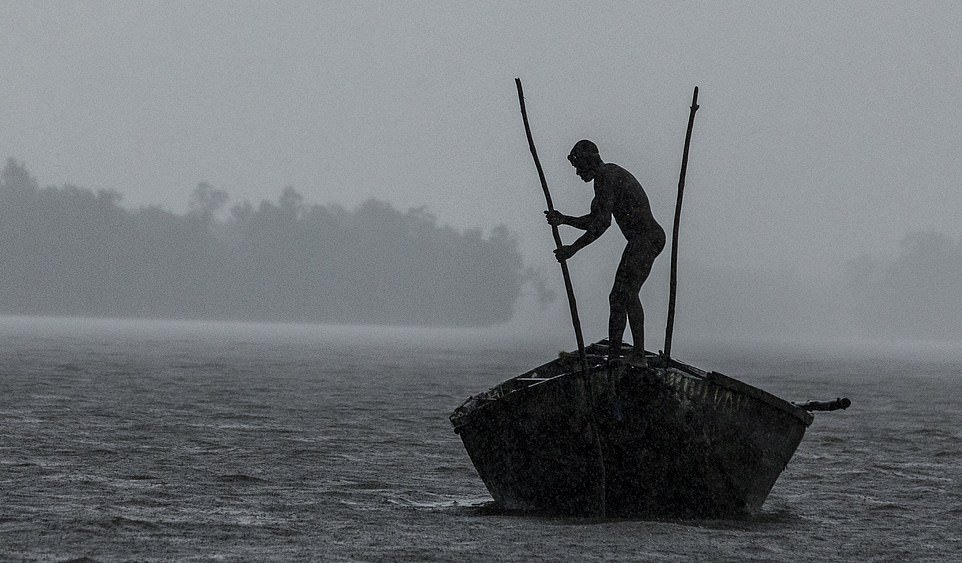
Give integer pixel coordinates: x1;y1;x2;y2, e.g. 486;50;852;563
450;341;848;517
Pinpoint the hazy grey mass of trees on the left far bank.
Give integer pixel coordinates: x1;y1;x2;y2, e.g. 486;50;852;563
0;159;526;325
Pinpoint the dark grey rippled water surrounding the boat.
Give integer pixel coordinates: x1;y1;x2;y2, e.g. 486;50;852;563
0;321;962;561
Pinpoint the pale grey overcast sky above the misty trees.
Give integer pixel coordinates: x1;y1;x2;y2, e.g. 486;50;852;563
0;1;962;282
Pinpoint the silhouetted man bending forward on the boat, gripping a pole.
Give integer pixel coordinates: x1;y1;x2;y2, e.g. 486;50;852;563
545;140;665;367
